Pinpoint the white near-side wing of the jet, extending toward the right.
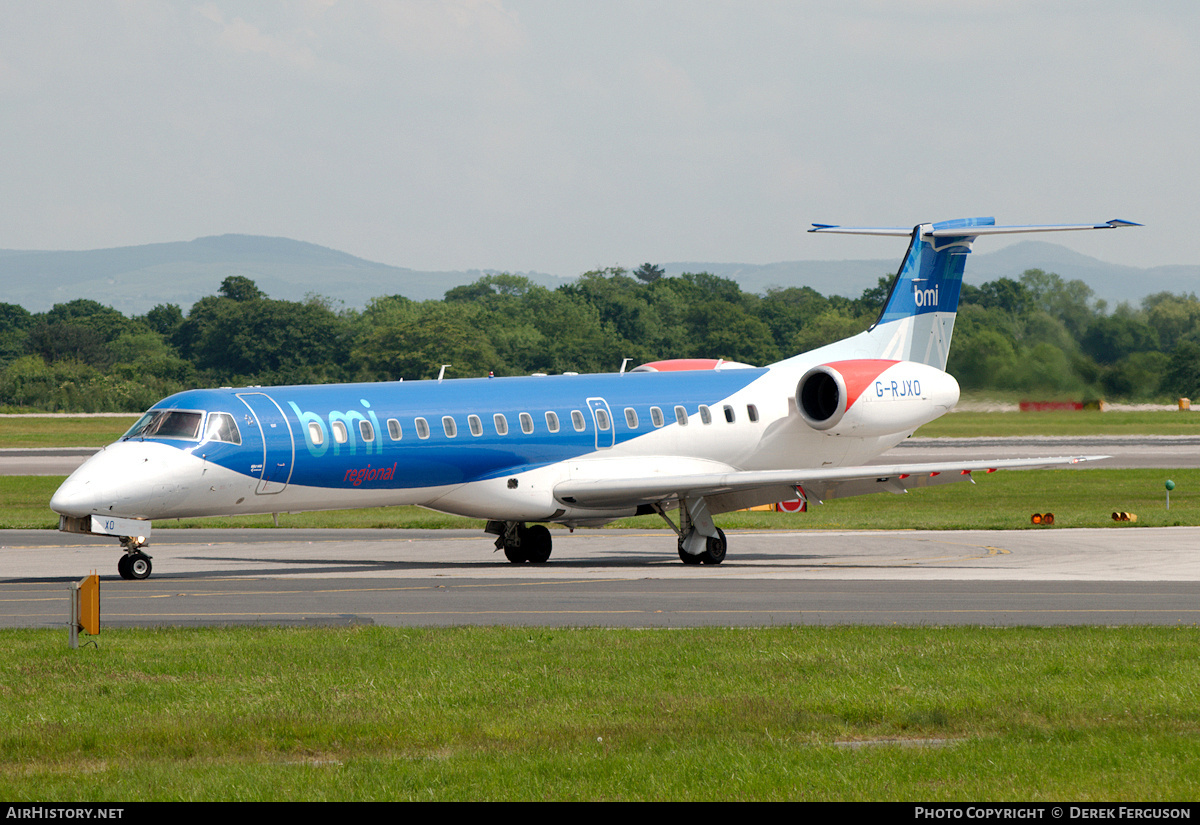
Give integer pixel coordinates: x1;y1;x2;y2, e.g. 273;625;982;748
554;456;1109;512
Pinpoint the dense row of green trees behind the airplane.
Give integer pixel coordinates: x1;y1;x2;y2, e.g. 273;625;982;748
0;264;1200;411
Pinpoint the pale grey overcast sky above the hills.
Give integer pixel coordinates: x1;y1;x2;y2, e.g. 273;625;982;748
0;0;1200;276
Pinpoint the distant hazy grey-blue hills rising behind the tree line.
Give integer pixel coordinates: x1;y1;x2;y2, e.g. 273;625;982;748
0;235;1200;315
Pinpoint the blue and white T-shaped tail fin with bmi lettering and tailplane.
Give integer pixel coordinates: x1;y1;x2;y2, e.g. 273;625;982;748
809;218;1141;369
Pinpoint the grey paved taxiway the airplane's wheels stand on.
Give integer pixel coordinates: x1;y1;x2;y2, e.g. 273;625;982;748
0;528;1200;628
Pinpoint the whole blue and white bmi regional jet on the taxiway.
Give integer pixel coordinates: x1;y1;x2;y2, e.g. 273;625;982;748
50;218;1140;579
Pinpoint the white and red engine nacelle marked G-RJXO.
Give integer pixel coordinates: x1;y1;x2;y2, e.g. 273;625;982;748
796;359;959;436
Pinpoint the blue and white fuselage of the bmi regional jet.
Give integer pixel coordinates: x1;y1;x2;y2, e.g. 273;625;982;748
52;362;958;523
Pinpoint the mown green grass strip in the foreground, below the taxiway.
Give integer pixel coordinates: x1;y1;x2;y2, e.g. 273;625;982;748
0;627;1200;802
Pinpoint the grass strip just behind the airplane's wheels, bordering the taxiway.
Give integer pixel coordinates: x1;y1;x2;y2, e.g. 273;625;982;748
0;469;1200;530
